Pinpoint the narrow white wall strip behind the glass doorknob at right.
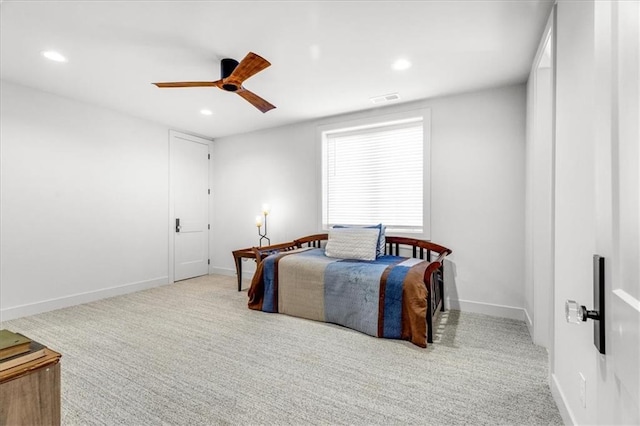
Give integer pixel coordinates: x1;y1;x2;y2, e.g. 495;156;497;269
552;1;597;424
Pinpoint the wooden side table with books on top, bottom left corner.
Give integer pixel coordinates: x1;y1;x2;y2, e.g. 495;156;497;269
0;348;61;425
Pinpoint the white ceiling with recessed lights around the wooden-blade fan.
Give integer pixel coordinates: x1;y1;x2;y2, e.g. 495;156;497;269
0;0;553;137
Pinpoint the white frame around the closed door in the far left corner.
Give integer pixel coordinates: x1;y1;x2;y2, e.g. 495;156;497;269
167;130;213;284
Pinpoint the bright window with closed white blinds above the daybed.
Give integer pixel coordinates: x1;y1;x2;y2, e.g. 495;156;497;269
320;110;429;238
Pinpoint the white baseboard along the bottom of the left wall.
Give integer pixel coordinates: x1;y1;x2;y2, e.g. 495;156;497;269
0;276;169;321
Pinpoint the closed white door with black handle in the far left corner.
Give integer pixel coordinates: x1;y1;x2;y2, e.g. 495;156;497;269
170;132;209;281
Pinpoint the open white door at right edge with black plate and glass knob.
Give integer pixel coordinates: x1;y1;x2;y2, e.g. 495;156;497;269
594;1;640;424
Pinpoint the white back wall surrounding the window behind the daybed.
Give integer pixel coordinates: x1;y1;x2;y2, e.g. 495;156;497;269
211;85;526;319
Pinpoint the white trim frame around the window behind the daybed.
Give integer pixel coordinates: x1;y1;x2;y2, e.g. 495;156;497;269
316;108;431;240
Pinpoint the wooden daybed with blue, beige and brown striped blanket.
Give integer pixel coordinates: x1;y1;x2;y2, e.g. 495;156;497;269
248;231;451;347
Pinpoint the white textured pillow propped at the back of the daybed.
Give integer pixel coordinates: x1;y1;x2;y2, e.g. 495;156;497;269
325;228;380;260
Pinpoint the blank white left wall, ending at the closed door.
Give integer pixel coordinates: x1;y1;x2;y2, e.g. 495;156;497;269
0;81;169;320
